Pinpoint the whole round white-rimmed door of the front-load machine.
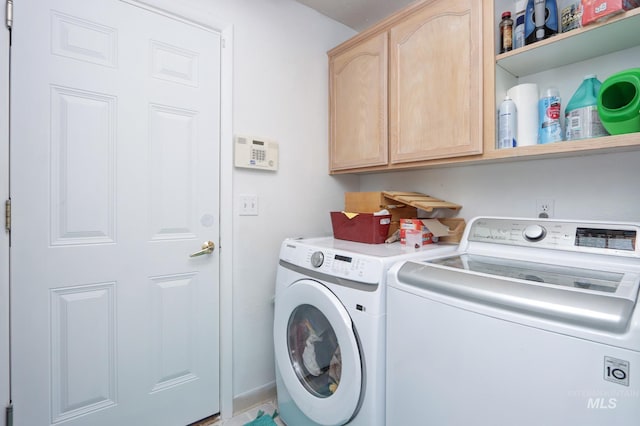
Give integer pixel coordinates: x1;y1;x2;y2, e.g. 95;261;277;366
273;279;363;425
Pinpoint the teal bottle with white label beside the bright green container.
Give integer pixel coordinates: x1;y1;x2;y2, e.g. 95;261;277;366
564;74;609;141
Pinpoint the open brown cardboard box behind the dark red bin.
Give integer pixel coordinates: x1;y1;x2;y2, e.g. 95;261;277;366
344;191;418;236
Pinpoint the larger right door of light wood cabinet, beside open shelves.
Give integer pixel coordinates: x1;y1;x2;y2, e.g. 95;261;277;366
389;0;483;163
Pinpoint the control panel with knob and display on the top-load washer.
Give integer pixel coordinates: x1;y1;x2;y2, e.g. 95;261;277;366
467;218;640;257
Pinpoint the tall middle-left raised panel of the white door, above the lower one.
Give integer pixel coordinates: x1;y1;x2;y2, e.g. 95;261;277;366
50;86;116;245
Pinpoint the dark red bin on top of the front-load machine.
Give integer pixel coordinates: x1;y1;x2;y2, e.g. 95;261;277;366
331;212;391;244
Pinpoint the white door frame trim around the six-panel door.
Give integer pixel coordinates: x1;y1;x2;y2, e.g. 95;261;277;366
0;0;234;420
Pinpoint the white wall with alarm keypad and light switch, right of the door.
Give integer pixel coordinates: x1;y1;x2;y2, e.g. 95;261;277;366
222;0;358;404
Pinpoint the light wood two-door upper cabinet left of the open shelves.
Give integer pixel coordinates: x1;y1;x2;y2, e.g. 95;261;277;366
329;0;483;173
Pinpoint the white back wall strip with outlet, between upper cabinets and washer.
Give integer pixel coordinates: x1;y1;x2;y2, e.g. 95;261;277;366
361;150;640;221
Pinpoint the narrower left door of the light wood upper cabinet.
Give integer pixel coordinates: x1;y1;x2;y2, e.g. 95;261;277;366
329;32;388;171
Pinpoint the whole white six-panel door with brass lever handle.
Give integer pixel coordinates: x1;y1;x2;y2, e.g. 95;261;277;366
11;0;220;426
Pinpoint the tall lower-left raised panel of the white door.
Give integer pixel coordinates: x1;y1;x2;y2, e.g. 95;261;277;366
50;283;117;422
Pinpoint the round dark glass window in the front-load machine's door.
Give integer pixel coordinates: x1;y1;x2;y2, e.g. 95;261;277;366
287;305;342;398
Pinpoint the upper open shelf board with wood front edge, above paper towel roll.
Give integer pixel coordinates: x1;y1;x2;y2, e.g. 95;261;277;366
496;8;640;77
